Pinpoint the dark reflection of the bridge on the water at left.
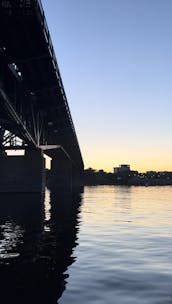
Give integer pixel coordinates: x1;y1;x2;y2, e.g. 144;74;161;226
0;190;81;304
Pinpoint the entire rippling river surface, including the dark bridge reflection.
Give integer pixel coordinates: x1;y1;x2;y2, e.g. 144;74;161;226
0;186;172;304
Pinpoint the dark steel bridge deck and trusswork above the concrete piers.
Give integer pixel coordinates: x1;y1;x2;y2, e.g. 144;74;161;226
0;0;83;170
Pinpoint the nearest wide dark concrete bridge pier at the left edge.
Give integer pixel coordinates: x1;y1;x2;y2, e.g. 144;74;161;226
0;150;45;193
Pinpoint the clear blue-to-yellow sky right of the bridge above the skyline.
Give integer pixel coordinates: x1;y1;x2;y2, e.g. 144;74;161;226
42;0;172;172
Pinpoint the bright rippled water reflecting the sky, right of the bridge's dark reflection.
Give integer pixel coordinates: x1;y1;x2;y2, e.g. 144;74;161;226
59;186;172;304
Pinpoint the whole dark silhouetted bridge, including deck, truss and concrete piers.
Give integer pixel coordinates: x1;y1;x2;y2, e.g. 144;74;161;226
0;0;84;192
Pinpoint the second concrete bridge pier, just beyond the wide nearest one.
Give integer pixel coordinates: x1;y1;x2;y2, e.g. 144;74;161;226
50;150;72;192
